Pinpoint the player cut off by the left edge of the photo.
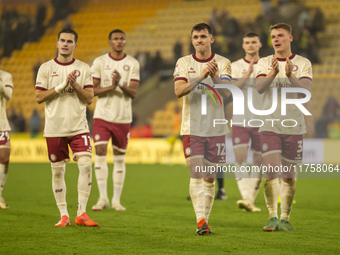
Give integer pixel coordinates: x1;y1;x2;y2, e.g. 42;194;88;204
0;70;13;209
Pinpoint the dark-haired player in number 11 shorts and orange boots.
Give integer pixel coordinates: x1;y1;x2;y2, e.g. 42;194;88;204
35;29;98;227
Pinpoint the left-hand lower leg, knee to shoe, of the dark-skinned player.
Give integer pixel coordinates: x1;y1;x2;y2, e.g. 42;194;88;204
92;144;110;211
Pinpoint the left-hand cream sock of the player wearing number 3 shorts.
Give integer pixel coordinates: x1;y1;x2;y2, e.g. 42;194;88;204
264;178;280;218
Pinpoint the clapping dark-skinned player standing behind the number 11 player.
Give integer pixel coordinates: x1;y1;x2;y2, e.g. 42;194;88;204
91;29;140;211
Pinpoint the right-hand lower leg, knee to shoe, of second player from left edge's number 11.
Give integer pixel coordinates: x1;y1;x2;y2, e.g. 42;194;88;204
112;149;126;211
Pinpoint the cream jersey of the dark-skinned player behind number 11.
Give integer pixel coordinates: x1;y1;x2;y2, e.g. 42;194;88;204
91;53;139;123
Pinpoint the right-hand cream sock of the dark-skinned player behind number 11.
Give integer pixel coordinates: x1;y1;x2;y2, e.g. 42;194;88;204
112;155;126;204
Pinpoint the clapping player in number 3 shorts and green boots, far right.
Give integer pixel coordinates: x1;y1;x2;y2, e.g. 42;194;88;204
256;23;313;231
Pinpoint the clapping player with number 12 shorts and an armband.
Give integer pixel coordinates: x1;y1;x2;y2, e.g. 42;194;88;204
174;23;231;235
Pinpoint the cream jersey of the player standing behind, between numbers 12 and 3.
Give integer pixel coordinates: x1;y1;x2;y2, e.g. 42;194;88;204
231;58;262;127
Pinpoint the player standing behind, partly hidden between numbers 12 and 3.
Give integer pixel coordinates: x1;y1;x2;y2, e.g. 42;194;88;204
231;32;262;212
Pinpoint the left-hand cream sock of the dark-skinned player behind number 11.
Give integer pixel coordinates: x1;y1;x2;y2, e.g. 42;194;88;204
94;155;109;200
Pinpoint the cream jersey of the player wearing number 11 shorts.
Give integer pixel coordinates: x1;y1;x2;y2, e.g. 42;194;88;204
35;59;93;137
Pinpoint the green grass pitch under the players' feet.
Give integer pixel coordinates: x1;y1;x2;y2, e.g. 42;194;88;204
0;163;340;254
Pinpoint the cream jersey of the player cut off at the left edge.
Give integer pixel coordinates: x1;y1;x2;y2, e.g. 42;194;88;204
0;70;13;131
